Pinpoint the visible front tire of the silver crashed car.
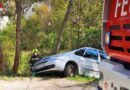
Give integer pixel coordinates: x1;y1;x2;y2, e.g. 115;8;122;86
64;64;77;77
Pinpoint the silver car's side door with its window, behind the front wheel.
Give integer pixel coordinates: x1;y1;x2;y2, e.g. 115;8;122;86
84;48;100;71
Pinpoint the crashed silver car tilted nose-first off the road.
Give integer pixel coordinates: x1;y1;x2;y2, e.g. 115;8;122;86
32;47;110;77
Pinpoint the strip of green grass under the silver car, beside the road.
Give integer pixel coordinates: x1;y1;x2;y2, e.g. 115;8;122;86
67;76;98;83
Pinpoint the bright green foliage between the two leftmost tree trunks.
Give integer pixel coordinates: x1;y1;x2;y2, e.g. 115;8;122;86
0;25;16;70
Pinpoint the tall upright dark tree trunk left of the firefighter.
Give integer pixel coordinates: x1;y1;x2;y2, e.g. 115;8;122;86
13;0;22;74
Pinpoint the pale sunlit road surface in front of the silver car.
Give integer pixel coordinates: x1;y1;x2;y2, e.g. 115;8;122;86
0;77;96;90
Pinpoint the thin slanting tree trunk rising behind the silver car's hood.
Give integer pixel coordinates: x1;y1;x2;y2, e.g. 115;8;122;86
55;0;73;53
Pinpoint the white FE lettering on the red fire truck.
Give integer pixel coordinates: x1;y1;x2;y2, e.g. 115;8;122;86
115;0;130;18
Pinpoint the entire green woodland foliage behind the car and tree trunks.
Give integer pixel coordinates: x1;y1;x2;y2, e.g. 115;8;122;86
0;0;103;75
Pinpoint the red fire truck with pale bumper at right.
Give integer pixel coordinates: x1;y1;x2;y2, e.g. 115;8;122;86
98;0;130;90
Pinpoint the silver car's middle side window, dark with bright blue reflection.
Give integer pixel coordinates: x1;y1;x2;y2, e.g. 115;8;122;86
85;49;98;60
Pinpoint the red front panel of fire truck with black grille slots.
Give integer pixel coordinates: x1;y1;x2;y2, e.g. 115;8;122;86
104;0;130;62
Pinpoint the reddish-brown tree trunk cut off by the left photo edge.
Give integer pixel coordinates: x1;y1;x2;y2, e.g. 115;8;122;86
0;40;5;73
